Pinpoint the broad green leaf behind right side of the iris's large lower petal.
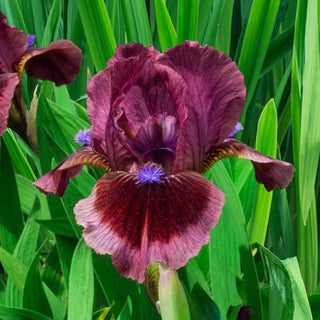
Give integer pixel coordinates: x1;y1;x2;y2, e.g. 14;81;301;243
205;161;261;319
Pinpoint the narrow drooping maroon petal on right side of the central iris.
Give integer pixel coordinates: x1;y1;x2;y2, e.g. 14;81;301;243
202;138;295;191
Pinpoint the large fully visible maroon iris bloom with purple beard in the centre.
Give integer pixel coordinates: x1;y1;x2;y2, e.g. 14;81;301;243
34;41;294;282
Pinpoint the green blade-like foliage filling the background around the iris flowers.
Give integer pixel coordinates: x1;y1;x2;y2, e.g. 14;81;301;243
0;0;320;320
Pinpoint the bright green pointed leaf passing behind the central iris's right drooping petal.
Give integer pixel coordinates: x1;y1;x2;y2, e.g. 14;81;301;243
248;99;277;245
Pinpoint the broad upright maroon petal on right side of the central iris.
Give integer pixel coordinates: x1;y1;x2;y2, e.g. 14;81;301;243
158;41;246;171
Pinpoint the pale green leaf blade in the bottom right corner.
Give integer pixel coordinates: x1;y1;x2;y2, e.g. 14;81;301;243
282;257;312;320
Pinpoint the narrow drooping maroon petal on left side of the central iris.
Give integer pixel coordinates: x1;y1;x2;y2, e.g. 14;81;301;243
33;146;110;197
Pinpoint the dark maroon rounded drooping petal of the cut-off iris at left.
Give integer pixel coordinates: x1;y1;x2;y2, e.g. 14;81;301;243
20;40;82;86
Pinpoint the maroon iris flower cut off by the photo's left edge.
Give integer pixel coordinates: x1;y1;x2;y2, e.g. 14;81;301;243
0;12;82;136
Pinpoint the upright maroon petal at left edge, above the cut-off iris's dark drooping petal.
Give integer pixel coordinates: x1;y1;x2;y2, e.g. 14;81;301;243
0;13;28;72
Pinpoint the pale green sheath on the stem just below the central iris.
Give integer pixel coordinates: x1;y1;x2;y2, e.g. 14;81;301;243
159;264;191;320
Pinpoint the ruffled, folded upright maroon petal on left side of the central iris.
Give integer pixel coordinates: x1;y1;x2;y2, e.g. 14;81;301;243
87;43;175;171
